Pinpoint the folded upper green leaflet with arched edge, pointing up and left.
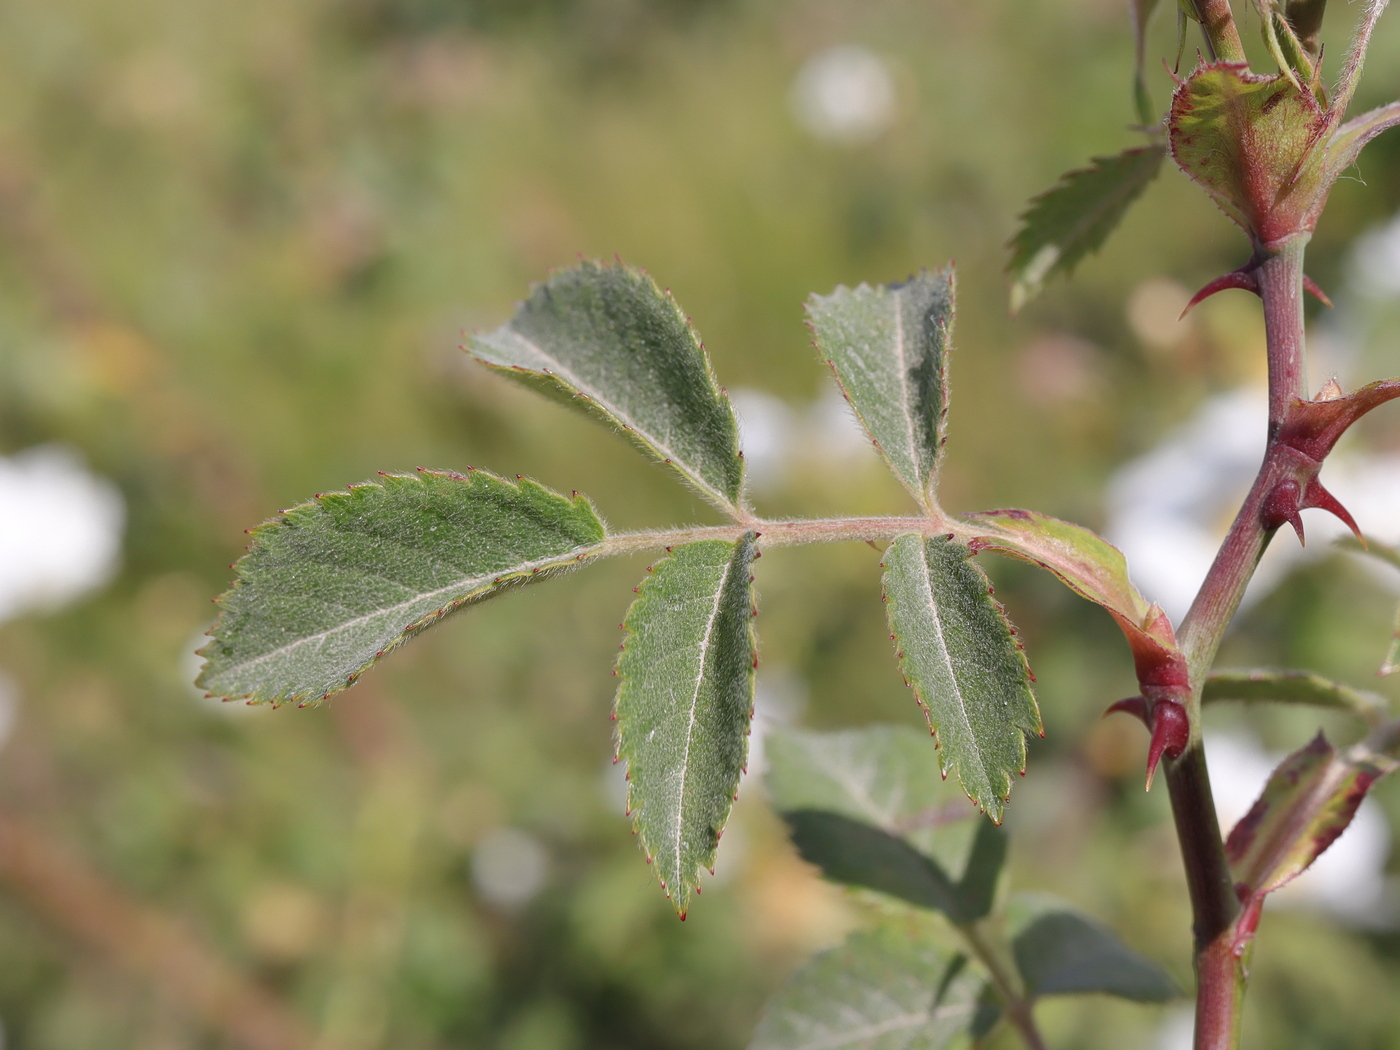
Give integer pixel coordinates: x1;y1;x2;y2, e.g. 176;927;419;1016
470;262;743;514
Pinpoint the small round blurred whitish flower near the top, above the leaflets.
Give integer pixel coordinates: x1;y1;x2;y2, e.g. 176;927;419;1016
792;43;895;144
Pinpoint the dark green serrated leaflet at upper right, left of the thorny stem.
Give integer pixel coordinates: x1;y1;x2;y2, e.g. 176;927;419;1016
1007;144;1165;311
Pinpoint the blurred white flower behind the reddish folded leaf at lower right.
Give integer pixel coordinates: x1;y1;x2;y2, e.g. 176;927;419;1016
1205;732;1394;927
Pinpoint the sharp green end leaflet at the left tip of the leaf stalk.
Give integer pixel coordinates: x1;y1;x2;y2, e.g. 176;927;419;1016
197;470;605;703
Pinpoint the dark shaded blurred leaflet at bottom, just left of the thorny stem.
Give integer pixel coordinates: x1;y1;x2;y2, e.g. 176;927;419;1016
1011;895;1182;1002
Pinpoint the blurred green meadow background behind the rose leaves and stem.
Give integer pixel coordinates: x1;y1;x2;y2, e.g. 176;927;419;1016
0;0;1400;1050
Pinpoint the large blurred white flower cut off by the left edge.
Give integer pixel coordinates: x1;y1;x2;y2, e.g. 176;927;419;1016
0;445;126;620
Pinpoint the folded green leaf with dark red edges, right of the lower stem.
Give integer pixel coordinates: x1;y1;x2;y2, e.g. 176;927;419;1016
1225;722;1400;902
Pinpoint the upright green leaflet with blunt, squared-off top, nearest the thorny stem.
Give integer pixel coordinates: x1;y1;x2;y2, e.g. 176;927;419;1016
806;270;953;507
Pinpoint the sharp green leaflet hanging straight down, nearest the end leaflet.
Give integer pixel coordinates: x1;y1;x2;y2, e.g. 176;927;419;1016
617;532;756;917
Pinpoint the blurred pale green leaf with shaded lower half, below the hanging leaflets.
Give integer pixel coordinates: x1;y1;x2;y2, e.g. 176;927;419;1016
766;725;1007;921
